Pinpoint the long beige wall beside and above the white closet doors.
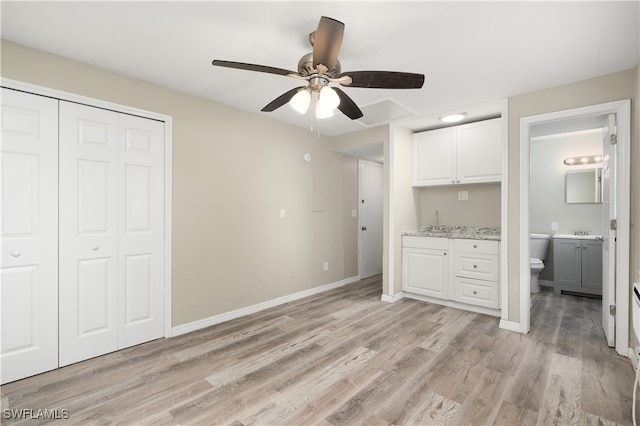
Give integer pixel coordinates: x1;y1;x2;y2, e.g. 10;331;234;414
1;41;357;326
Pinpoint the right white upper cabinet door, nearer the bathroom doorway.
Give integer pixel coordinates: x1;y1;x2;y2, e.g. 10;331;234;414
456;118;502;183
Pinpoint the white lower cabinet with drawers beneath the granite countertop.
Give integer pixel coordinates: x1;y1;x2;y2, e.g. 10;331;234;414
402;236;500;314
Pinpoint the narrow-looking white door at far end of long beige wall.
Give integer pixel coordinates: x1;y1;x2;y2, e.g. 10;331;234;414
358;160;384;278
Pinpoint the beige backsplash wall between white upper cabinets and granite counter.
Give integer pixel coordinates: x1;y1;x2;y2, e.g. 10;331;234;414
420;183;500;227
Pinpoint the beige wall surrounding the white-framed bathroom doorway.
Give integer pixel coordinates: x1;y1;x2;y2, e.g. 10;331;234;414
507;68;640;323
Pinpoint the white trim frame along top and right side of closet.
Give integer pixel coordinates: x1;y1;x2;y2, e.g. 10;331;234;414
0;78;173;337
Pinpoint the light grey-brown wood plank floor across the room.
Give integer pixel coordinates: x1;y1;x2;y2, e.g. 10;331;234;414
2;277;634;425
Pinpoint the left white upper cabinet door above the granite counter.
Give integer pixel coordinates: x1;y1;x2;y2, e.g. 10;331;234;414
413;128;455;186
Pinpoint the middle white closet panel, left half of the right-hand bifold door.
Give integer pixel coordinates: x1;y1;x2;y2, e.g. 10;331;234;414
59;101;118;366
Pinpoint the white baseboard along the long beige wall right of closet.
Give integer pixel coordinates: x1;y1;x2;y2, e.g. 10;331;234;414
171;277;359;337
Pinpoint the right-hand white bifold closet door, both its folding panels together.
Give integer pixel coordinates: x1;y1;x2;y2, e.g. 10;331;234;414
59;101;164;366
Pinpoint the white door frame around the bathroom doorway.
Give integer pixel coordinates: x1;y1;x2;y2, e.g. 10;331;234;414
519;99;631;356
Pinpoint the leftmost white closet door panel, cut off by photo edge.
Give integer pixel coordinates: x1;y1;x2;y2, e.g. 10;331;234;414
0;89;58;384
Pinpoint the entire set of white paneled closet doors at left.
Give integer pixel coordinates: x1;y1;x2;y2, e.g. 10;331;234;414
0;88;165;384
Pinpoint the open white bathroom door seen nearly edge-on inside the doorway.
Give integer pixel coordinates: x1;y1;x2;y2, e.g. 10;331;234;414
602;114;618;347
